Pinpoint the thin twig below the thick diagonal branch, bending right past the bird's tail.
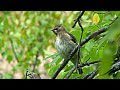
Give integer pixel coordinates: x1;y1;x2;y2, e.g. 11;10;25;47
65;60;100;79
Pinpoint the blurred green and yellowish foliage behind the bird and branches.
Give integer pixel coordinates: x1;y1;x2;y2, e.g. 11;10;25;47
0;11;120;79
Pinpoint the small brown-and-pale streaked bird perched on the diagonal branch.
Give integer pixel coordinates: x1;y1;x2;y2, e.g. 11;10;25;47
52;25;83;74
